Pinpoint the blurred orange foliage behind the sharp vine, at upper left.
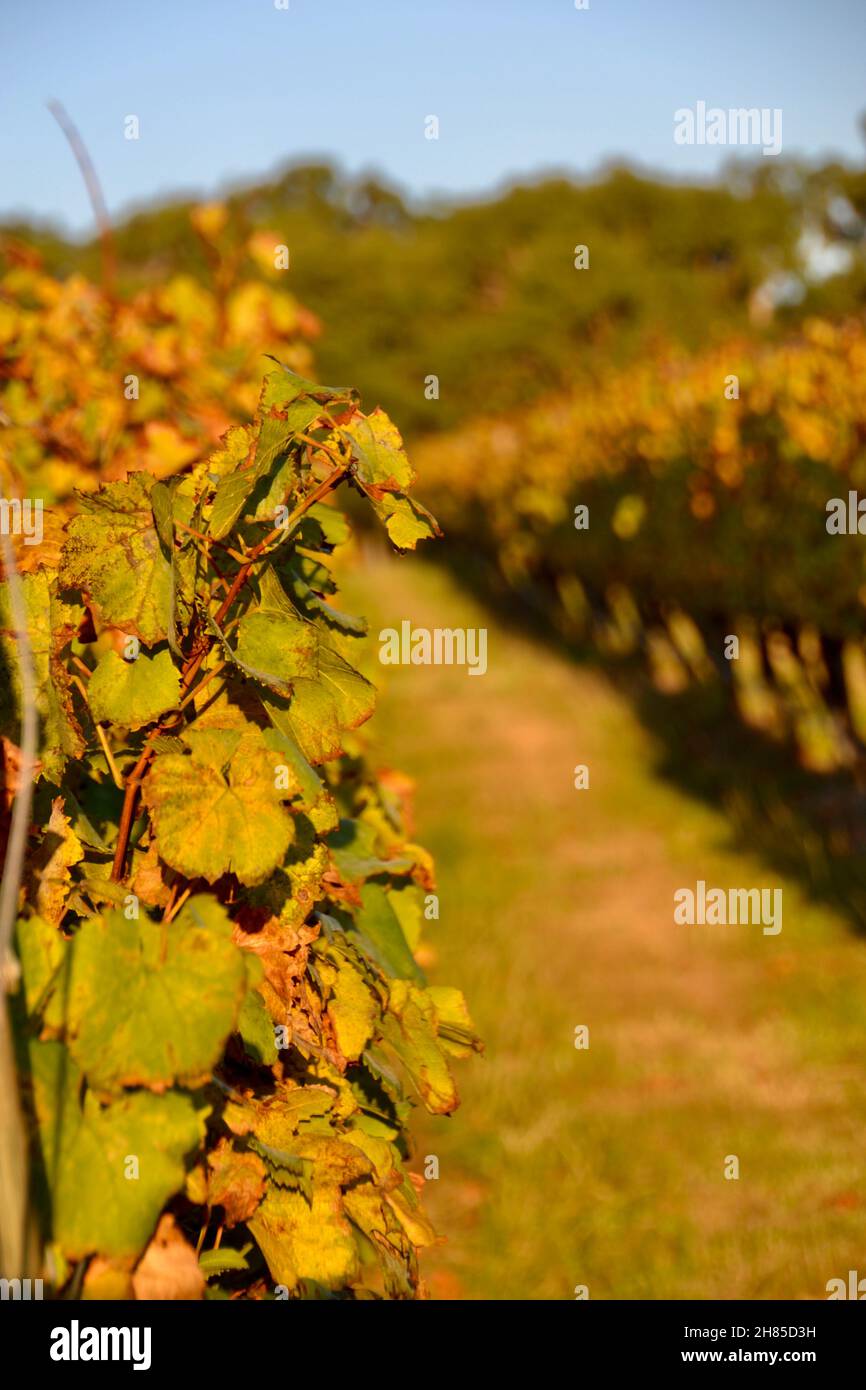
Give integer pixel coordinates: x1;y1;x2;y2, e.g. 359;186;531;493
0;222;318;502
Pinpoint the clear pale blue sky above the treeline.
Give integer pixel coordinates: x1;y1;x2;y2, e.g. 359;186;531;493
0;0;866;231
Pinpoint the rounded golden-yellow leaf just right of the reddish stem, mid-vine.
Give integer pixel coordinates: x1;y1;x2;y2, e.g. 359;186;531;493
142;726;295;884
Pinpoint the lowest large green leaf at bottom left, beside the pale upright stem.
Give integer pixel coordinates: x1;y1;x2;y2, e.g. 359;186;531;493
29;1043;207;1261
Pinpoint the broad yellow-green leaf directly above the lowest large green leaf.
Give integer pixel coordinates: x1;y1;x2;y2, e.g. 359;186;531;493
67;897;246;1091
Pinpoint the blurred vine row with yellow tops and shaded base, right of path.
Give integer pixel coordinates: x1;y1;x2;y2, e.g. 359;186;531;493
418;320;866;771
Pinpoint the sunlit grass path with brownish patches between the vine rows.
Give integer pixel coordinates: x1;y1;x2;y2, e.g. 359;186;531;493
343;556;866;1298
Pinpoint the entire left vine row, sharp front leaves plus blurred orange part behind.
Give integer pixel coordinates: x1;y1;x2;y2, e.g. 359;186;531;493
0;230;480;1298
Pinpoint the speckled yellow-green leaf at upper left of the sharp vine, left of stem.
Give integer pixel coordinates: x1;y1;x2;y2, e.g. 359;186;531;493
60;473;172;646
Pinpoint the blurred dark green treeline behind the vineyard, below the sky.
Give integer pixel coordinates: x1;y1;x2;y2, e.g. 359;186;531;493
7;150;866;434
